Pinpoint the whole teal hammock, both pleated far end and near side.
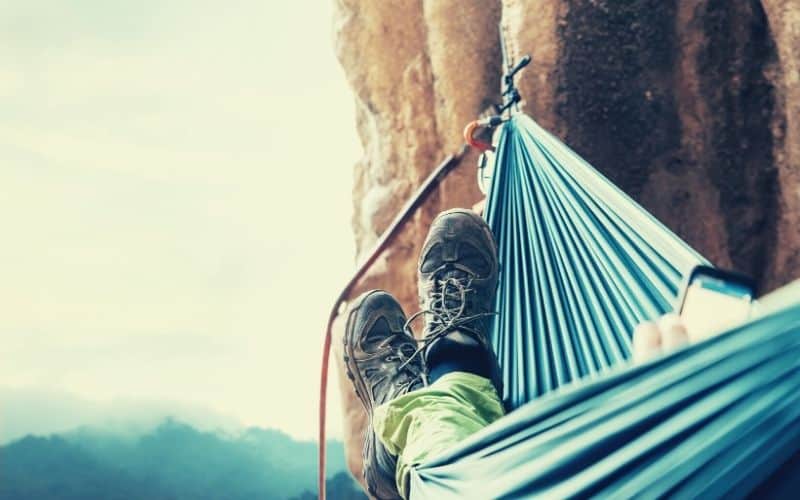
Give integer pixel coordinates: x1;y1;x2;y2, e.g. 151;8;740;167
411;114;800;499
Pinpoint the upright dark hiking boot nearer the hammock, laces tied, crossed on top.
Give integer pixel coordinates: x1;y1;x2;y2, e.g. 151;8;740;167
418;209;502;395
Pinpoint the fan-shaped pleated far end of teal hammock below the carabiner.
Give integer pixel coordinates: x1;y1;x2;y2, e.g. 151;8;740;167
486;114;706;408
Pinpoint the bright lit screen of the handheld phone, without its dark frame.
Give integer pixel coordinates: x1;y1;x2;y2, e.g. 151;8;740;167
681;274;753;341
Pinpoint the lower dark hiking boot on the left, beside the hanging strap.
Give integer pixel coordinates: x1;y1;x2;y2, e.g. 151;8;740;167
344;290;424;500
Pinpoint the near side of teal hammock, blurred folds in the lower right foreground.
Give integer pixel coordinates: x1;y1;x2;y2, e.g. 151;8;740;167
411;288;800;499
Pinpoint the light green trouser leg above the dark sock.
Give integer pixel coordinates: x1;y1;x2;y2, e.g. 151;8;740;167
372;372;504;498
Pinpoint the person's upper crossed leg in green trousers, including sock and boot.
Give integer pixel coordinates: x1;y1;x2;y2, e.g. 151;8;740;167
373;209;504;498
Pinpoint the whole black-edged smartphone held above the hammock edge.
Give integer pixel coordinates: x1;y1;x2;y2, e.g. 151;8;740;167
677;266;756;341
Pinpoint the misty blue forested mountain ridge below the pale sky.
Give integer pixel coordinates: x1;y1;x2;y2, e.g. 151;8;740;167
0;419;366;500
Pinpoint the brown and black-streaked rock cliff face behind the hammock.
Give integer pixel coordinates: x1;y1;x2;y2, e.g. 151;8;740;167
334;0;800;492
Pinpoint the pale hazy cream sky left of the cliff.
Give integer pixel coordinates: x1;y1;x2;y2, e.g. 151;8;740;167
0;0;360;437
